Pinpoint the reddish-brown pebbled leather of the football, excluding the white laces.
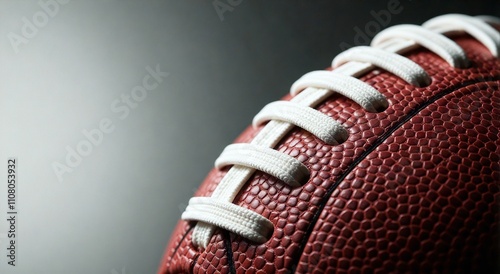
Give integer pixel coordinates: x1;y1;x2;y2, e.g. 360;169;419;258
158;35;500;273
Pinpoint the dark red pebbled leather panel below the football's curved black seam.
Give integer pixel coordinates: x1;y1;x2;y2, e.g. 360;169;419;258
298;82;500;273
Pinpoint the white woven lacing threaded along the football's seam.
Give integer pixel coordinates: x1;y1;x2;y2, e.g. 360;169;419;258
182;14;500;248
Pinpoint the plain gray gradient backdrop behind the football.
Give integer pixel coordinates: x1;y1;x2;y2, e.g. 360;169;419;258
0;0;500;274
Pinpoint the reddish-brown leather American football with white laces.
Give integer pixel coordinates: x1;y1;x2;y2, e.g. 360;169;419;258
158;14;500;274
